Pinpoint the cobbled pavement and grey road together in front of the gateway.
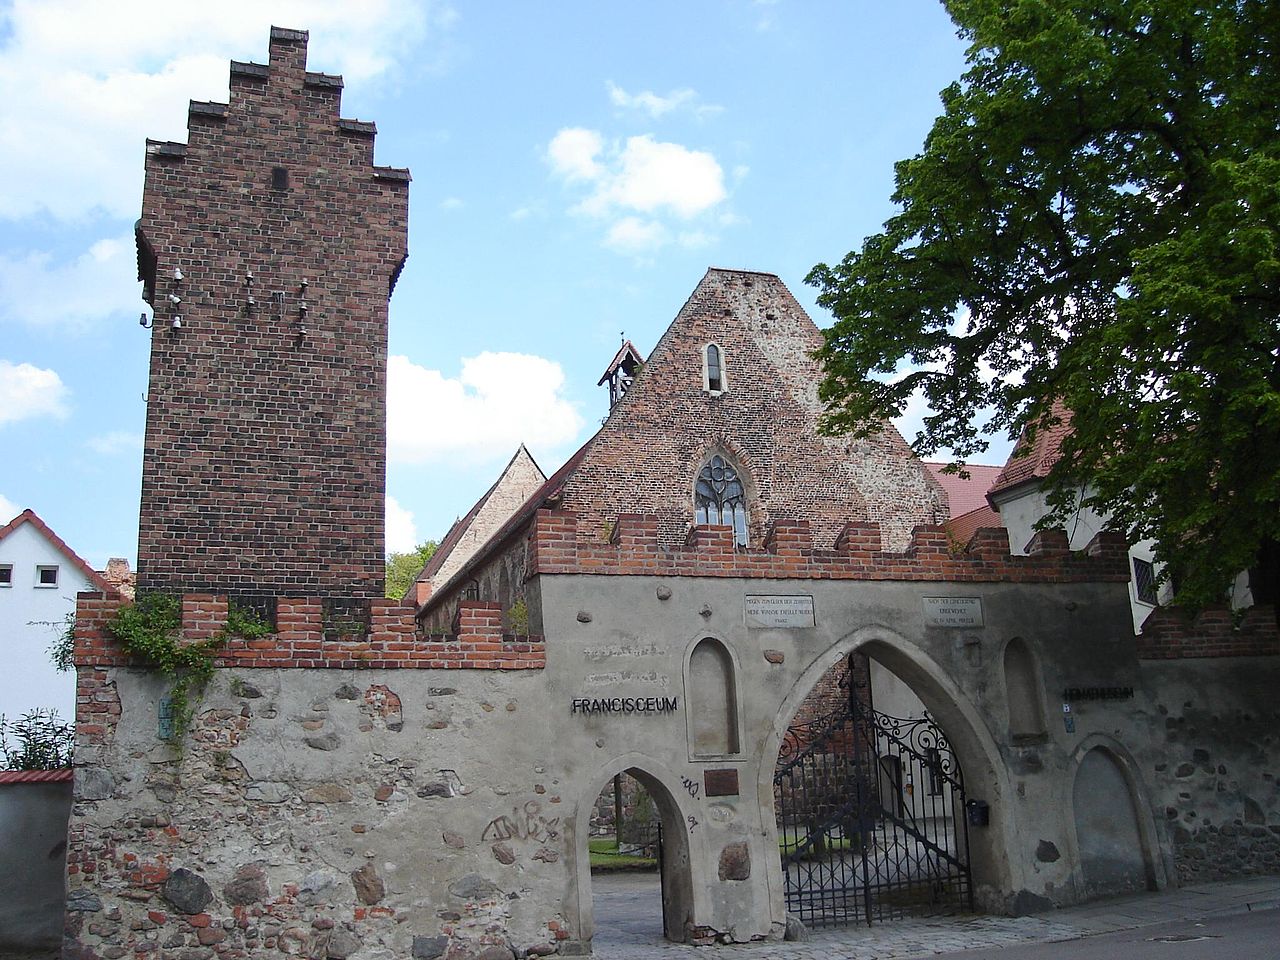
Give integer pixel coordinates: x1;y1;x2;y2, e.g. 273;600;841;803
591;874;1280;960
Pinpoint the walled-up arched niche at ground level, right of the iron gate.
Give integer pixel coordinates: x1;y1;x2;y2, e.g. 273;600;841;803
1071;746;1156;900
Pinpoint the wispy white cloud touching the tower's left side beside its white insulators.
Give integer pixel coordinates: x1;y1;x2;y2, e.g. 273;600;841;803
0;236;143;332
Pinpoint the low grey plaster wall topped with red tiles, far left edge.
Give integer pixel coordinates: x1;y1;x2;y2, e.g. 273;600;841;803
0;782;72;955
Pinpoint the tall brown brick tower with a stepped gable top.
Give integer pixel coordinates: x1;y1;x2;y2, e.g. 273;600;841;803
137;27;410;599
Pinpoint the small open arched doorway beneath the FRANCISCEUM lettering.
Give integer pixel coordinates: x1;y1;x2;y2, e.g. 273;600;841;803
576;760;694;943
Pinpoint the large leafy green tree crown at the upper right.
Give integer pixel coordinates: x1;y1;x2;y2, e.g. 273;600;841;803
809;0;1280;603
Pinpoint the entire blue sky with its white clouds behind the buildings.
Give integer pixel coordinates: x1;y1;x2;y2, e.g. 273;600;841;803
0;0;1007;567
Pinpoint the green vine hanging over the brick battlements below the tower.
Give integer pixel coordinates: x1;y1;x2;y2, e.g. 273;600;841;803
106;594;271;751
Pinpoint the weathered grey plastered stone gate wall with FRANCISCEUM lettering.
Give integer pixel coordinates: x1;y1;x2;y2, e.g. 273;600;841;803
69;576;1147;957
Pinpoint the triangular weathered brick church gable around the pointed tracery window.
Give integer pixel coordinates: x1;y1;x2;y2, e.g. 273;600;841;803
561;269;946;549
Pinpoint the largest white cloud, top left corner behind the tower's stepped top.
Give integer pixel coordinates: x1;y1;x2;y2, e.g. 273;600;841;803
0;0;440;219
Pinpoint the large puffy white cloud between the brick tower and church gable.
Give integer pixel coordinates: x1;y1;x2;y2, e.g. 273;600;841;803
387;352;582;465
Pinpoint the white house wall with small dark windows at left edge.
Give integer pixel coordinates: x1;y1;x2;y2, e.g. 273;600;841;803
0;524;96;721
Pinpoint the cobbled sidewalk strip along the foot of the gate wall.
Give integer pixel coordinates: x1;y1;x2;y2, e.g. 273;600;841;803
591;874;1280;960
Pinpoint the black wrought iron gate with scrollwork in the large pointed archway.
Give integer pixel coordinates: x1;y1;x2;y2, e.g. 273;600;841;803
773;696;973;927
